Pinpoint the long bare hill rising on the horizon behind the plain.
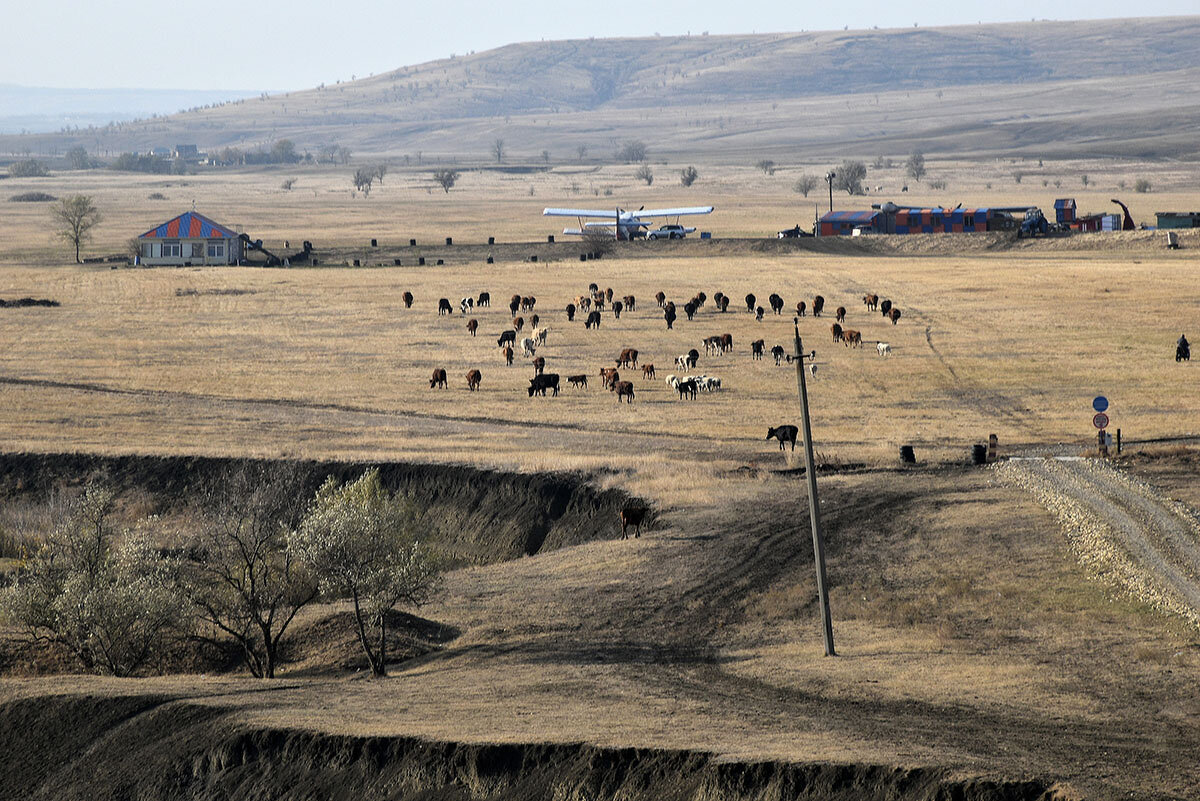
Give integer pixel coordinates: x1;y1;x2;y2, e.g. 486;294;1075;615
0;17;1200;163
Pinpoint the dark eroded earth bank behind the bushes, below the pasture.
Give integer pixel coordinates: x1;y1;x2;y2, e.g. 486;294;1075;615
0;453;644;564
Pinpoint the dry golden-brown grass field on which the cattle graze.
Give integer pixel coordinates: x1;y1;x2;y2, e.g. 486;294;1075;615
0;162;1200;797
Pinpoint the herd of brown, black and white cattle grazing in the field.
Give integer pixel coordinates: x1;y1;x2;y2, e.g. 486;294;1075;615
402;283;900;407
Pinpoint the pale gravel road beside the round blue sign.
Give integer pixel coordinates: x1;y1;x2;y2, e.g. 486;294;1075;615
997;458;1200;627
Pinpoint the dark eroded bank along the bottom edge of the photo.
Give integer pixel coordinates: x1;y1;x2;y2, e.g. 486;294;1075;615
0;695;1048;801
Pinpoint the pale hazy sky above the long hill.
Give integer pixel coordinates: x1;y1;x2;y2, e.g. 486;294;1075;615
9;0;1200;91
